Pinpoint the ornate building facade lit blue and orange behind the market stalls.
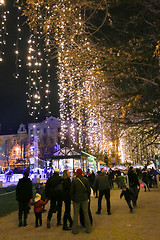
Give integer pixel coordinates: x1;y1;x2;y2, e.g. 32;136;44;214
0;116;74;169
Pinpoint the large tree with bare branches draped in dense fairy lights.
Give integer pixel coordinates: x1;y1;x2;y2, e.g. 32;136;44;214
23;0;160;161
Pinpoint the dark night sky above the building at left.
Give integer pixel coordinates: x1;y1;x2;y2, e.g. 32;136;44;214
0;0;59;134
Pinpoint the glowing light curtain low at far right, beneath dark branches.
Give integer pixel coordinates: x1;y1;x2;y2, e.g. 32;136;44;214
119;126;160;165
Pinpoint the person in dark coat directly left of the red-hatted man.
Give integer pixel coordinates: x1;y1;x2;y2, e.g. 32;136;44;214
63;170;73;231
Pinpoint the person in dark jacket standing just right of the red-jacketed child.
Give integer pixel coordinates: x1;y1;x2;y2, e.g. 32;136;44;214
45;168;63;228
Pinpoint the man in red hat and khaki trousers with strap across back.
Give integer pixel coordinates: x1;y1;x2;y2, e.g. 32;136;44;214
71;168;92;234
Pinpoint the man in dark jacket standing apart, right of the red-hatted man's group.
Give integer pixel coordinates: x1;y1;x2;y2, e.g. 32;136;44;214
94;168;111;215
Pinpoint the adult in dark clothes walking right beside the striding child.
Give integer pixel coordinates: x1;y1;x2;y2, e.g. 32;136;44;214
128;167;140;207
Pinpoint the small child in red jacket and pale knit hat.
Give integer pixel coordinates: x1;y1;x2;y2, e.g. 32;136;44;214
30;193;48;227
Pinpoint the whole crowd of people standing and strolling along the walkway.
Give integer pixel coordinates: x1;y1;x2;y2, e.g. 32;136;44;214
16;167;157;234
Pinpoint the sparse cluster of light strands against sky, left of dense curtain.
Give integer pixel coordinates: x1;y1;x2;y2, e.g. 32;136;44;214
26;26;51;120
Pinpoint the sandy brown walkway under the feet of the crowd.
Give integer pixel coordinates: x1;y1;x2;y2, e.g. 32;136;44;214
0;188;160;240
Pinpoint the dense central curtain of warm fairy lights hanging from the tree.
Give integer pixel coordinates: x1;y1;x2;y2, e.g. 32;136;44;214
52;1;110;151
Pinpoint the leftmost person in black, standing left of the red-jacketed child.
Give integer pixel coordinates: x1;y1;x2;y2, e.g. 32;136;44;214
16;172;32;227
